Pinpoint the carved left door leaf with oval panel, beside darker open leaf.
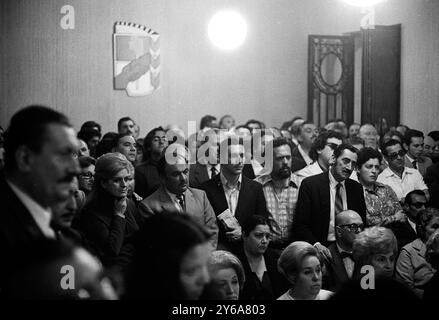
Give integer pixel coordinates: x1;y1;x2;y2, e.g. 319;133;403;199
308;35;354;127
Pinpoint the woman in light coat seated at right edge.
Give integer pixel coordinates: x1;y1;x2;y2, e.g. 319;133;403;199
396;208;439;298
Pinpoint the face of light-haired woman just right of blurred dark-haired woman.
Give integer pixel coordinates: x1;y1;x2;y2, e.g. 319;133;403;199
210;268;240;300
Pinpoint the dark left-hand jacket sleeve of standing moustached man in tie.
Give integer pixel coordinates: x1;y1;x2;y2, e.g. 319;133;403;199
291;179;318;244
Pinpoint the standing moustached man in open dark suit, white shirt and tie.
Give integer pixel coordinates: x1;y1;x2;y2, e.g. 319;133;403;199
291;144;366;259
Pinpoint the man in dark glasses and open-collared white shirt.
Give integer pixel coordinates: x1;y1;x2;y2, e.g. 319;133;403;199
377;139;430;203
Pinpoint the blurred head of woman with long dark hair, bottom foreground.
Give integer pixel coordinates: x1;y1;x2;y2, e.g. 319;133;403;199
125;211;211;301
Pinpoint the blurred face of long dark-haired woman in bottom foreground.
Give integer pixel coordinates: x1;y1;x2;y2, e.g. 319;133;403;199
180;243;210;300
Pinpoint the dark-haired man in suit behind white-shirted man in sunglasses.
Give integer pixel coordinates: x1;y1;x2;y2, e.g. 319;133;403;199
404;129;433;176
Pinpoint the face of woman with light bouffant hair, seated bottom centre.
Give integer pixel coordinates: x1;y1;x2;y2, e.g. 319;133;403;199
294;256;322;300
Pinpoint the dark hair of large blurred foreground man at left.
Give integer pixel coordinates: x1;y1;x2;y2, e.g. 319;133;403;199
4;105;71;171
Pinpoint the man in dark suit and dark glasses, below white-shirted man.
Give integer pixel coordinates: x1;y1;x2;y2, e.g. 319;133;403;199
386;190;427;250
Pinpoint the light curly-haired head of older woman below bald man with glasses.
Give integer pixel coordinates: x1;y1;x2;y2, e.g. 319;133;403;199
352;226;398;278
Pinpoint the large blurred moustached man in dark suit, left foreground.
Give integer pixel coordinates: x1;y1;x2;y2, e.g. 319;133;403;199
0;106;80;287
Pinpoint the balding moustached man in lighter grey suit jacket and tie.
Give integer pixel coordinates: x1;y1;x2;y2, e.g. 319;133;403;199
139;144;218;250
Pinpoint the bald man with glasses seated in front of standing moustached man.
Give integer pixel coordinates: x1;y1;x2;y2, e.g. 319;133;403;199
324;210;364;290
